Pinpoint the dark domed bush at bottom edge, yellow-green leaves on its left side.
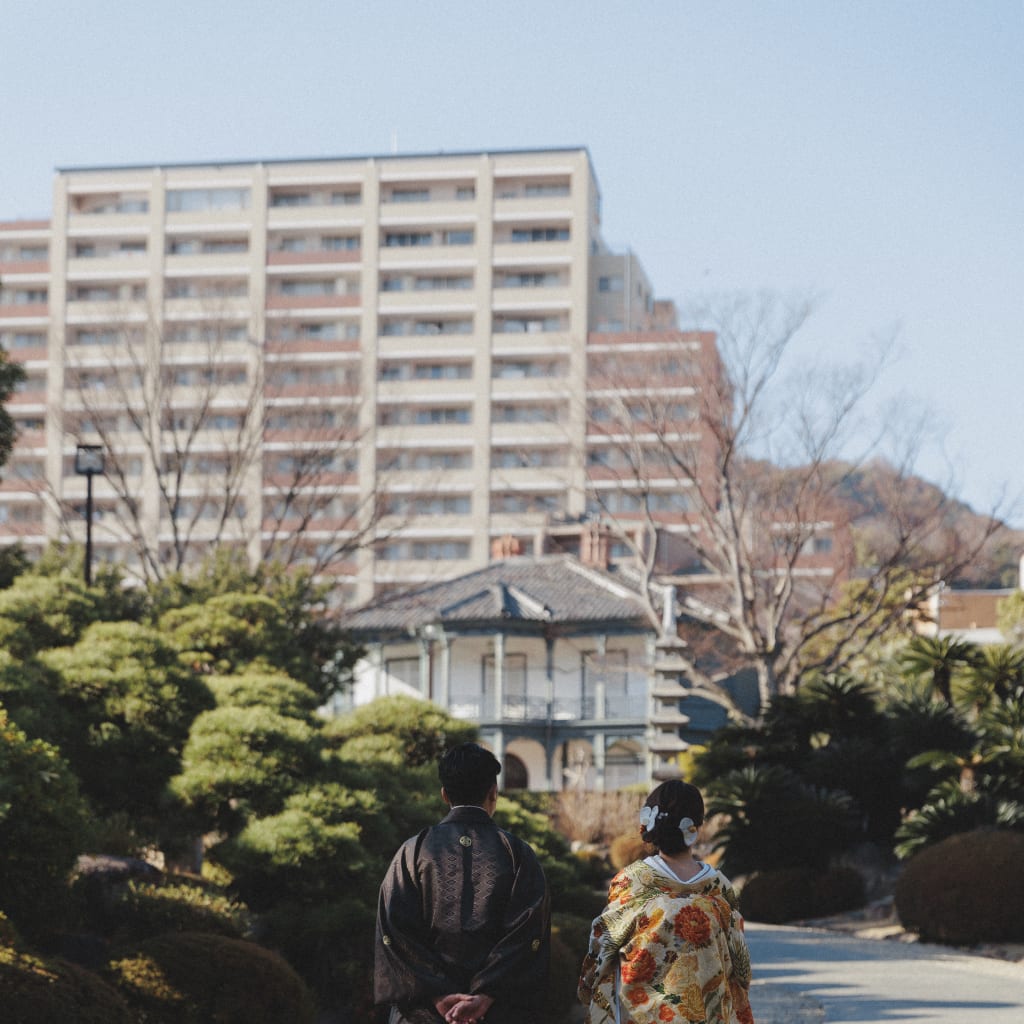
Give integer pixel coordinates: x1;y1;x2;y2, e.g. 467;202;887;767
111;932;313;1024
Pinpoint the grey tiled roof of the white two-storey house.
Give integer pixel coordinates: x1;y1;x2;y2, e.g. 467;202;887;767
343;555;649;635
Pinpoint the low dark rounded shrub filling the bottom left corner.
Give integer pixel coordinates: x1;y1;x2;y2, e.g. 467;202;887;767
0;946;137;1024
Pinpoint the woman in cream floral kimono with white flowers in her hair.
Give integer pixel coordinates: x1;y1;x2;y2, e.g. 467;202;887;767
579;779;754;1024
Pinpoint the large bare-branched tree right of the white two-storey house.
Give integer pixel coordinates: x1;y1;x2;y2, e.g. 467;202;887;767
588;295;998;707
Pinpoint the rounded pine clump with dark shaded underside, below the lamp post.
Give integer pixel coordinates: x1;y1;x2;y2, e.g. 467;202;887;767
40;623;213;818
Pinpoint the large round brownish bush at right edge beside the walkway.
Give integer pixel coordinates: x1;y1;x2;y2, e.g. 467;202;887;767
895;829;1024;945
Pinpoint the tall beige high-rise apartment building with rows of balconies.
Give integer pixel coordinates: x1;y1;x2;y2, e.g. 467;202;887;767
0;148;713;601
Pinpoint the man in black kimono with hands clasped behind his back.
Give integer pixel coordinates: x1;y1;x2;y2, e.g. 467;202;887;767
374;743;551;1024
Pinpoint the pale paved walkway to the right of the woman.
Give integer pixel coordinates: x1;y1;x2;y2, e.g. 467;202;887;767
746;924;1024;1024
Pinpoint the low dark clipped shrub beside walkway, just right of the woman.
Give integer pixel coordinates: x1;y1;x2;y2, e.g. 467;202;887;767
739;867;865;925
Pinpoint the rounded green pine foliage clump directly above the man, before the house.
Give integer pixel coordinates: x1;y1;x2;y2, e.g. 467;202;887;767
324;696;476;766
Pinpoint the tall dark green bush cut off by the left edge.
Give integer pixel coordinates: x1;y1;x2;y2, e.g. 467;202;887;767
0;708;87;932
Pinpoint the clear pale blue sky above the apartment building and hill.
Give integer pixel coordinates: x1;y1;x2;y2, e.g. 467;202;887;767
6;0;1024;527
